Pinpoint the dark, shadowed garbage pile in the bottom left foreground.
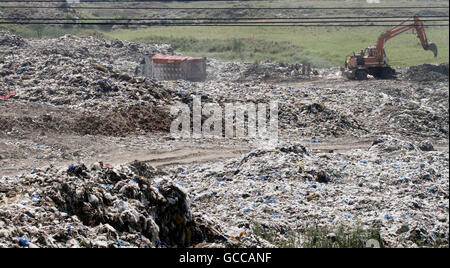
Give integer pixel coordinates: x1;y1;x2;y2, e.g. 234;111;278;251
0;162;227;248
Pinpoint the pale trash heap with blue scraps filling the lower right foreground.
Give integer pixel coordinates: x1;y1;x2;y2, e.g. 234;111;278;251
170;139;449;247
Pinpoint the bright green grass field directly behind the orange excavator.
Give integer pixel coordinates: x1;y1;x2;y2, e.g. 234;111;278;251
104;26;449;67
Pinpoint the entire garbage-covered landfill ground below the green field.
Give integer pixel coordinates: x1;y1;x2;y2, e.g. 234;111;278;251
0;4;449;248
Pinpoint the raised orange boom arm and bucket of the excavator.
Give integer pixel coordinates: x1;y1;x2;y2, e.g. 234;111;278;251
376;16;438;57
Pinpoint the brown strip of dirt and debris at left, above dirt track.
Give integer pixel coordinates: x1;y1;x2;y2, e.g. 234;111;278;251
0;104;171;137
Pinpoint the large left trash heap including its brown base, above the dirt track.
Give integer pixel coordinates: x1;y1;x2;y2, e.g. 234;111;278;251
0;32;182;136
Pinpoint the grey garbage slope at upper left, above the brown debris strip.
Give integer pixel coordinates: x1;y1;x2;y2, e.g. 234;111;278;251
0;32;176;110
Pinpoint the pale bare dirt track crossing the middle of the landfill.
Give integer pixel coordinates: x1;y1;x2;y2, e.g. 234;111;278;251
0;131;449;176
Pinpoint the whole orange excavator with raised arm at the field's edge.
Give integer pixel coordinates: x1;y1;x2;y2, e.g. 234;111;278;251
343;16;438;80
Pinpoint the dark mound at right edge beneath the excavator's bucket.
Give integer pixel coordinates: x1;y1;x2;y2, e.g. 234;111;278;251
406;62;448;82
